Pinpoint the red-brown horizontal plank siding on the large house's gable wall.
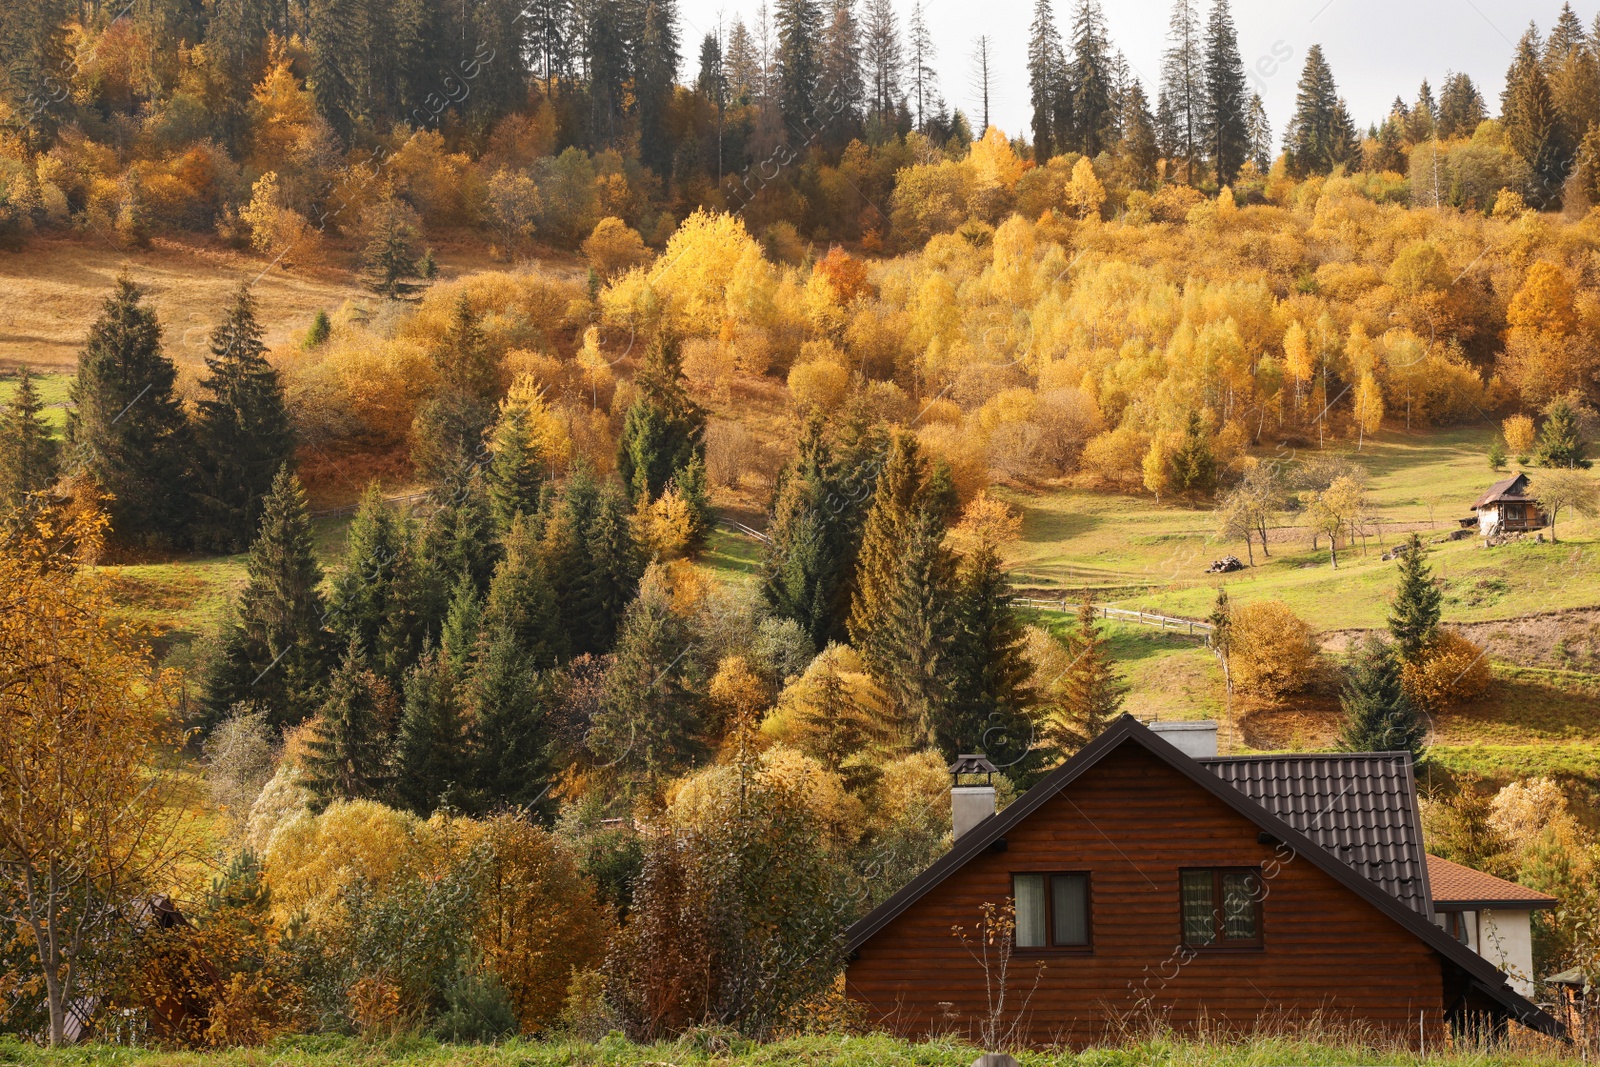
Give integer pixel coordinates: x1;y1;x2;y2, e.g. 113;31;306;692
846;744;1445;1046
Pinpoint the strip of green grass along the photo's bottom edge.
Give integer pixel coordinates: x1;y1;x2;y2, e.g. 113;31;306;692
0;1032;1579;1067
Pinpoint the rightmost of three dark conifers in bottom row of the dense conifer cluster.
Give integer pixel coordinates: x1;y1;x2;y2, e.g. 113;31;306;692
467;627;557;819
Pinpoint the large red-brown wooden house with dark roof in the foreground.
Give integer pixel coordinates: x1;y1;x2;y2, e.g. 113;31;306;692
845;717;1562;1046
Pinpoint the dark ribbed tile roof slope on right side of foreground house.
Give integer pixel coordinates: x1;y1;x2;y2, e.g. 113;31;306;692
1200;752;1434;918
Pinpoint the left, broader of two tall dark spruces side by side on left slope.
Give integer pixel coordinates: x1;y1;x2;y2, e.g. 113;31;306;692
67;277;194;547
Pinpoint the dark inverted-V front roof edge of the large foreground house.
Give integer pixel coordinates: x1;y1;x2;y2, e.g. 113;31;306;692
845;715;1565;1037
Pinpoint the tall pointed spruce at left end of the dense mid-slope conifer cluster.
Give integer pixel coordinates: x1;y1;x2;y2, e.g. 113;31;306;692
205;467;328;726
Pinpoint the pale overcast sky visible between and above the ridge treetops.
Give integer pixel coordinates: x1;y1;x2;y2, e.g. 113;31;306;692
680;0;1574;138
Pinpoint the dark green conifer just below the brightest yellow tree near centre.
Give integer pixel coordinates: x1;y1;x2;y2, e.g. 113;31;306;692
616;331;706;501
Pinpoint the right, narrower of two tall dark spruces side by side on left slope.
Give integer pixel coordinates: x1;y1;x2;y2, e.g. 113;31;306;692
195;286;294;552
